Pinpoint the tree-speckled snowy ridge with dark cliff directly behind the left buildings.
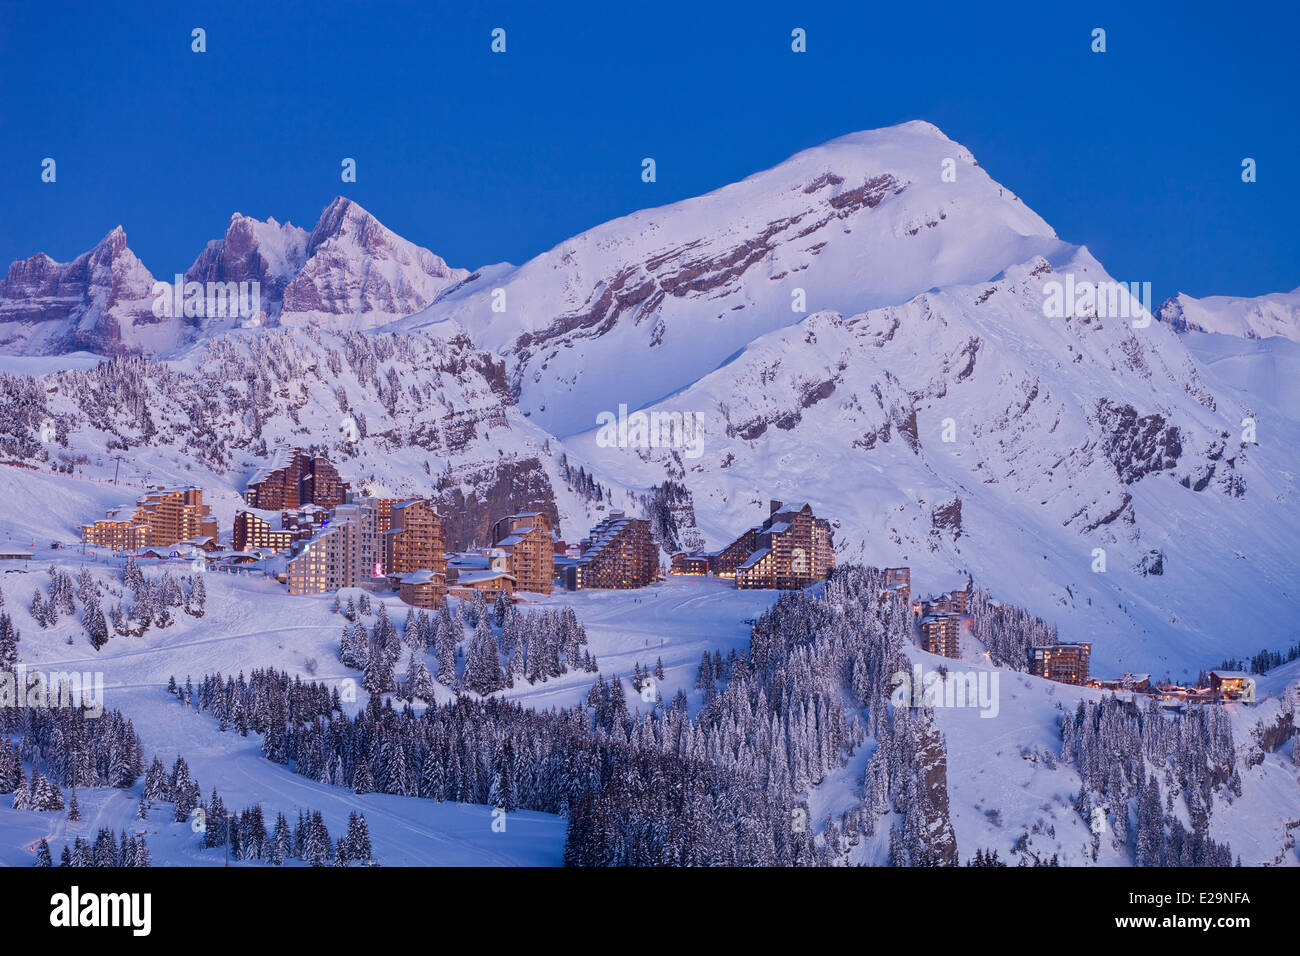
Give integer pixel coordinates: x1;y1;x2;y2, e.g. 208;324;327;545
0;329;618;548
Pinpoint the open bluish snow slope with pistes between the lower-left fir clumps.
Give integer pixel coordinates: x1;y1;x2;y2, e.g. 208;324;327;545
0;467;566;866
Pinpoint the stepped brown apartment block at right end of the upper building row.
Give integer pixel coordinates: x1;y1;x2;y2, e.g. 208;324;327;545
710;501;835;591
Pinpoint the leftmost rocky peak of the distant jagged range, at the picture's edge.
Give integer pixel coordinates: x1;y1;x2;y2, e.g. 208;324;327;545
0;226;180;355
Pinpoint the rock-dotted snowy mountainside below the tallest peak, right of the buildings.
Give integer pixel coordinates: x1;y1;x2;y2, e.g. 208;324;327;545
566;250;1300;676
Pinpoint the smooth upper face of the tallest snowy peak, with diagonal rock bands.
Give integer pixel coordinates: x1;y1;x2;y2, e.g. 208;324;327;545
399;122;1062;436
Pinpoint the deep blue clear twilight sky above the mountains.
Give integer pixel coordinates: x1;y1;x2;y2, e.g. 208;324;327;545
0;0;1300;300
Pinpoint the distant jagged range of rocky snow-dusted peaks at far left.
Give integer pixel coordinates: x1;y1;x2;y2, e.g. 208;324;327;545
0;196;469;356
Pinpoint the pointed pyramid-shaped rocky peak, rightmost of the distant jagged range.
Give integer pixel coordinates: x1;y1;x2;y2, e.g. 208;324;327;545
280;196;469;329
